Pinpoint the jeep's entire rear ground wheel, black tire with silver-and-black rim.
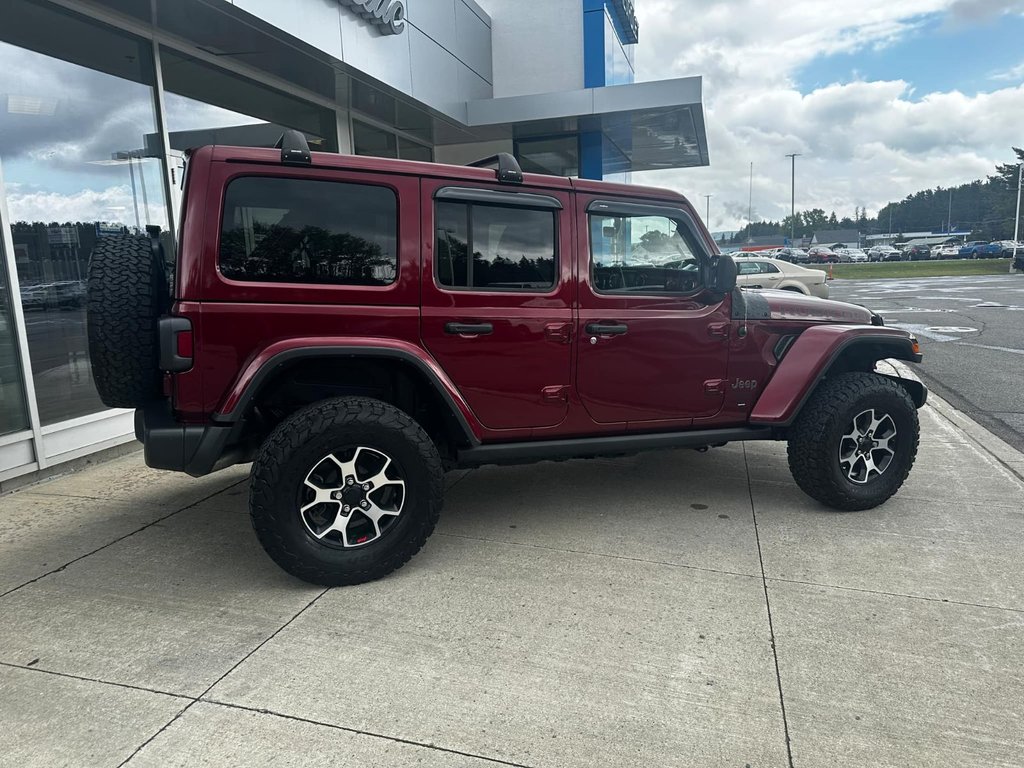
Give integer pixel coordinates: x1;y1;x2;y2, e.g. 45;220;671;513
250;397;443;587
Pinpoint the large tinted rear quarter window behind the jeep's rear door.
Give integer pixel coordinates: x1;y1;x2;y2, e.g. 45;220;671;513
220;176;398;286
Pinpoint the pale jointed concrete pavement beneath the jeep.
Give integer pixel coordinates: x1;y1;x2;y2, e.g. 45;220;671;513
0;401;1024;768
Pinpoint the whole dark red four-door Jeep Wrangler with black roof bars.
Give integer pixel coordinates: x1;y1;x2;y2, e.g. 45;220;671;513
88;133;927;585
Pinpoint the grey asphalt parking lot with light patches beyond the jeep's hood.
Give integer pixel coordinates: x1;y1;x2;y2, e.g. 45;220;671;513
830;274;1024;451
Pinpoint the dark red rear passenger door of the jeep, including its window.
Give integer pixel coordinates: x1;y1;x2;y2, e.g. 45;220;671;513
420;181;573;430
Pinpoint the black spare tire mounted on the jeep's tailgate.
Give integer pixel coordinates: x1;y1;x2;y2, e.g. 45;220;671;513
86;234;169;408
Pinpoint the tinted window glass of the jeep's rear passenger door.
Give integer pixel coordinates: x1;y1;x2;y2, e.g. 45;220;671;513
435;203;556;291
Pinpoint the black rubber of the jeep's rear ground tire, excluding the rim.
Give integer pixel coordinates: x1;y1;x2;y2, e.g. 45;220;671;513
249;397;444;587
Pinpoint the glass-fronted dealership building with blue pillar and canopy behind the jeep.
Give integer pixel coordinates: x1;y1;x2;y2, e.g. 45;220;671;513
0;0;709;484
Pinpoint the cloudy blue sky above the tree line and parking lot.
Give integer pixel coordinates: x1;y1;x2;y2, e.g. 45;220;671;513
634;0;1024;230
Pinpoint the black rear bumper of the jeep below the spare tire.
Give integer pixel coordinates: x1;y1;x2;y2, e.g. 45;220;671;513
135;400;241;477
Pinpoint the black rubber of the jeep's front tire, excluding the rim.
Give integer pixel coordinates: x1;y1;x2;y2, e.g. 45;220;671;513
787;373;920;511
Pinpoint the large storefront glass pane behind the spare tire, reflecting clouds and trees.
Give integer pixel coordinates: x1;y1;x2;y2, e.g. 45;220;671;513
0;0;167;425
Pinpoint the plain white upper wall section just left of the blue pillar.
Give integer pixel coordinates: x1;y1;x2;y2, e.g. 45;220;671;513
480;0;584;98
